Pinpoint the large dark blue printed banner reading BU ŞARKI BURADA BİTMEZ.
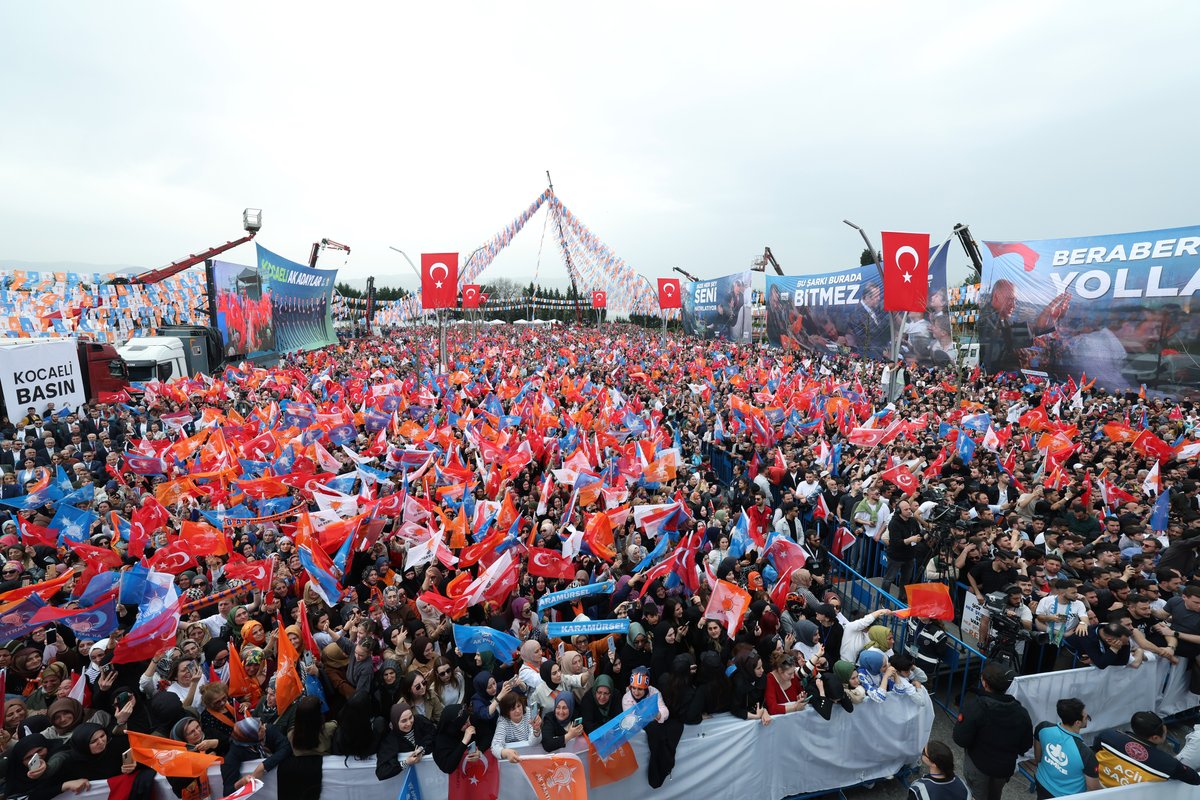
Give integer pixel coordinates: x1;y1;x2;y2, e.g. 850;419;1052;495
767;247;958;365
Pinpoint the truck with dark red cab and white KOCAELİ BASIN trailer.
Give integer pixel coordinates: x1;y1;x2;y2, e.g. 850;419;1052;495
0;336;130;415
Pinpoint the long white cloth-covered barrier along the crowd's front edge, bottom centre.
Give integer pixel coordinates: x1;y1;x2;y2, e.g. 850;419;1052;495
63;693;934;800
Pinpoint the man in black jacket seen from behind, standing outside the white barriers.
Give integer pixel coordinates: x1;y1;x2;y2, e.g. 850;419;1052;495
954;661;1033;800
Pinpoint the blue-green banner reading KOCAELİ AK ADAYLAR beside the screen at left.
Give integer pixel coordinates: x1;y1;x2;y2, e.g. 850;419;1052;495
257;245;337;353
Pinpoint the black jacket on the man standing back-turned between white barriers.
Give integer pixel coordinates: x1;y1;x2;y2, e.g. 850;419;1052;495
954;690;1033;777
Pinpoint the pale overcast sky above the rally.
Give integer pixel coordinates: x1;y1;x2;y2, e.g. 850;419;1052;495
0;0;1200;287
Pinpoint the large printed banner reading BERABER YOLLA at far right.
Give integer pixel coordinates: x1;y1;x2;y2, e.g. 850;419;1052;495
978;227;1200;397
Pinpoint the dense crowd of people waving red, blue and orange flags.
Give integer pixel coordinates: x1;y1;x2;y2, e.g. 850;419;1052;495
0;325;1200;800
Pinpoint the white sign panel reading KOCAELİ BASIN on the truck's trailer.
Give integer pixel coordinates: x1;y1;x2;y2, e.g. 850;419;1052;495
0;341;86;420
